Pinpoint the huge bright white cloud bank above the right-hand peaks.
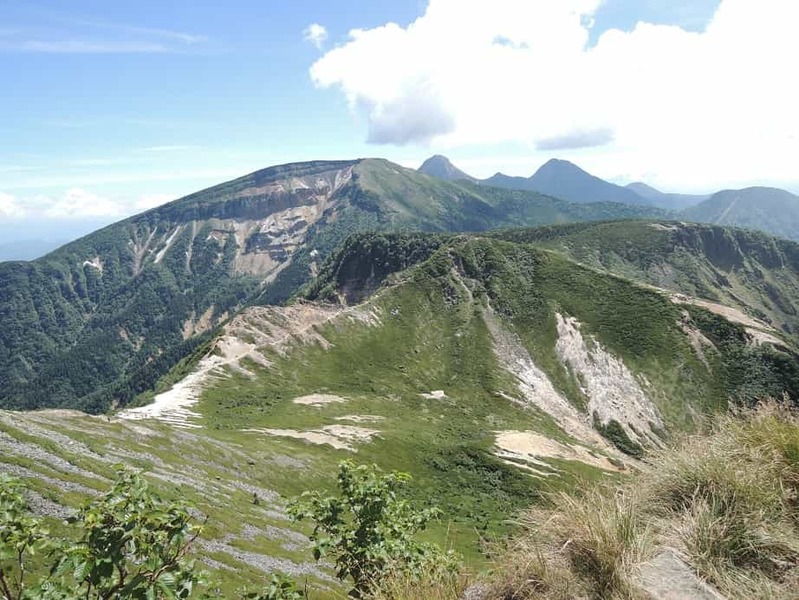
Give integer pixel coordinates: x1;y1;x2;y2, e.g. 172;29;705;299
310;0;799;186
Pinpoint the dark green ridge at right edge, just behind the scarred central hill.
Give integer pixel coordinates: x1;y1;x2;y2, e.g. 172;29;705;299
496;221;799;334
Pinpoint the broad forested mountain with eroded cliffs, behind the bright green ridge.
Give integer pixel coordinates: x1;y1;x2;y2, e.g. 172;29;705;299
0;159;664;411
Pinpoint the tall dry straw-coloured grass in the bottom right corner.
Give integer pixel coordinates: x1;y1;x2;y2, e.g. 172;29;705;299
372;402;799;600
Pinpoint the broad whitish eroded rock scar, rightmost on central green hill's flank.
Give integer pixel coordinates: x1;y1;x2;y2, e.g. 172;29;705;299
555;314;664;446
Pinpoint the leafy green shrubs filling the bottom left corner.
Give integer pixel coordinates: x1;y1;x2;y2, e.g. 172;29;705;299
0;469;203;600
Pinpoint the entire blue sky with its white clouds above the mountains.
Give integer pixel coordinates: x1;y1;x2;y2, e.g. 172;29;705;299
0;0;799;248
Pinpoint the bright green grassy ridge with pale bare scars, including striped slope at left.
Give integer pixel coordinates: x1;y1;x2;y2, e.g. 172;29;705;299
0;227;797;589
